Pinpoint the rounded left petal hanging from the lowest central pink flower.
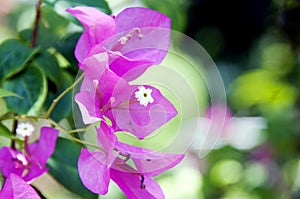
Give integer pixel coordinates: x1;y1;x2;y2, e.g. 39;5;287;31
78;148;110;195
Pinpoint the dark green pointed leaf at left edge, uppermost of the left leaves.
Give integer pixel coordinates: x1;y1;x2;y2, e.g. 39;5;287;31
0;39;38;79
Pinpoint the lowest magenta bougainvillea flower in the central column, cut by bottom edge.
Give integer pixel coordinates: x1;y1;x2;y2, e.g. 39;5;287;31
78;122;184;198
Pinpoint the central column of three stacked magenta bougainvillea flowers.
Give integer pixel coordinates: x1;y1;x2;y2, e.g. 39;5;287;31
67;7;184;198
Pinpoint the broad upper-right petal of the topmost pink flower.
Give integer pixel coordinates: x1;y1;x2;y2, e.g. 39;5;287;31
116;8;171;67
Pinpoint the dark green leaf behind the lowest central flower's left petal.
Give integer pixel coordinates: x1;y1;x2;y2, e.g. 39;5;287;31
47;138;98;199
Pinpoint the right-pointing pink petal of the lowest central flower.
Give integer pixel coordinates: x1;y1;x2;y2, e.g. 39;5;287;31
116;142;184;176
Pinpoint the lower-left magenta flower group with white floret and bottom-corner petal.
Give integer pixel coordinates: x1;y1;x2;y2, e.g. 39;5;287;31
0;126;58;199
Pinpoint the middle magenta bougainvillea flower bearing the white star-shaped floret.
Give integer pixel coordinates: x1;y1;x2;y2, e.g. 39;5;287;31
75;53;177;139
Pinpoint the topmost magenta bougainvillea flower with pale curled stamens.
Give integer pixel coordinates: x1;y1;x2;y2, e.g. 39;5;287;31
67;7;170;80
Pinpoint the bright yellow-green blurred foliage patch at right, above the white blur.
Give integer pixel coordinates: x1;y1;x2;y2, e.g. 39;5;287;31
230;70;297;114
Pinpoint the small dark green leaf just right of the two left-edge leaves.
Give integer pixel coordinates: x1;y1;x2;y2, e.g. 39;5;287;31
34;52;60;82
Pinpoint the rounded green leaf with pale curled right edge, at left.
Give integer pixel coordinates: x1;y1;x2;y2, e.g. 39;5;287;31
3;66;47;115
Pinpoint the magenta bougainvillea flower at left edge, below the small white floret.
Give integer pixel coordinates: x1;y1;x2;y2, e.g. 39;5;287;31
0;127;58;183
